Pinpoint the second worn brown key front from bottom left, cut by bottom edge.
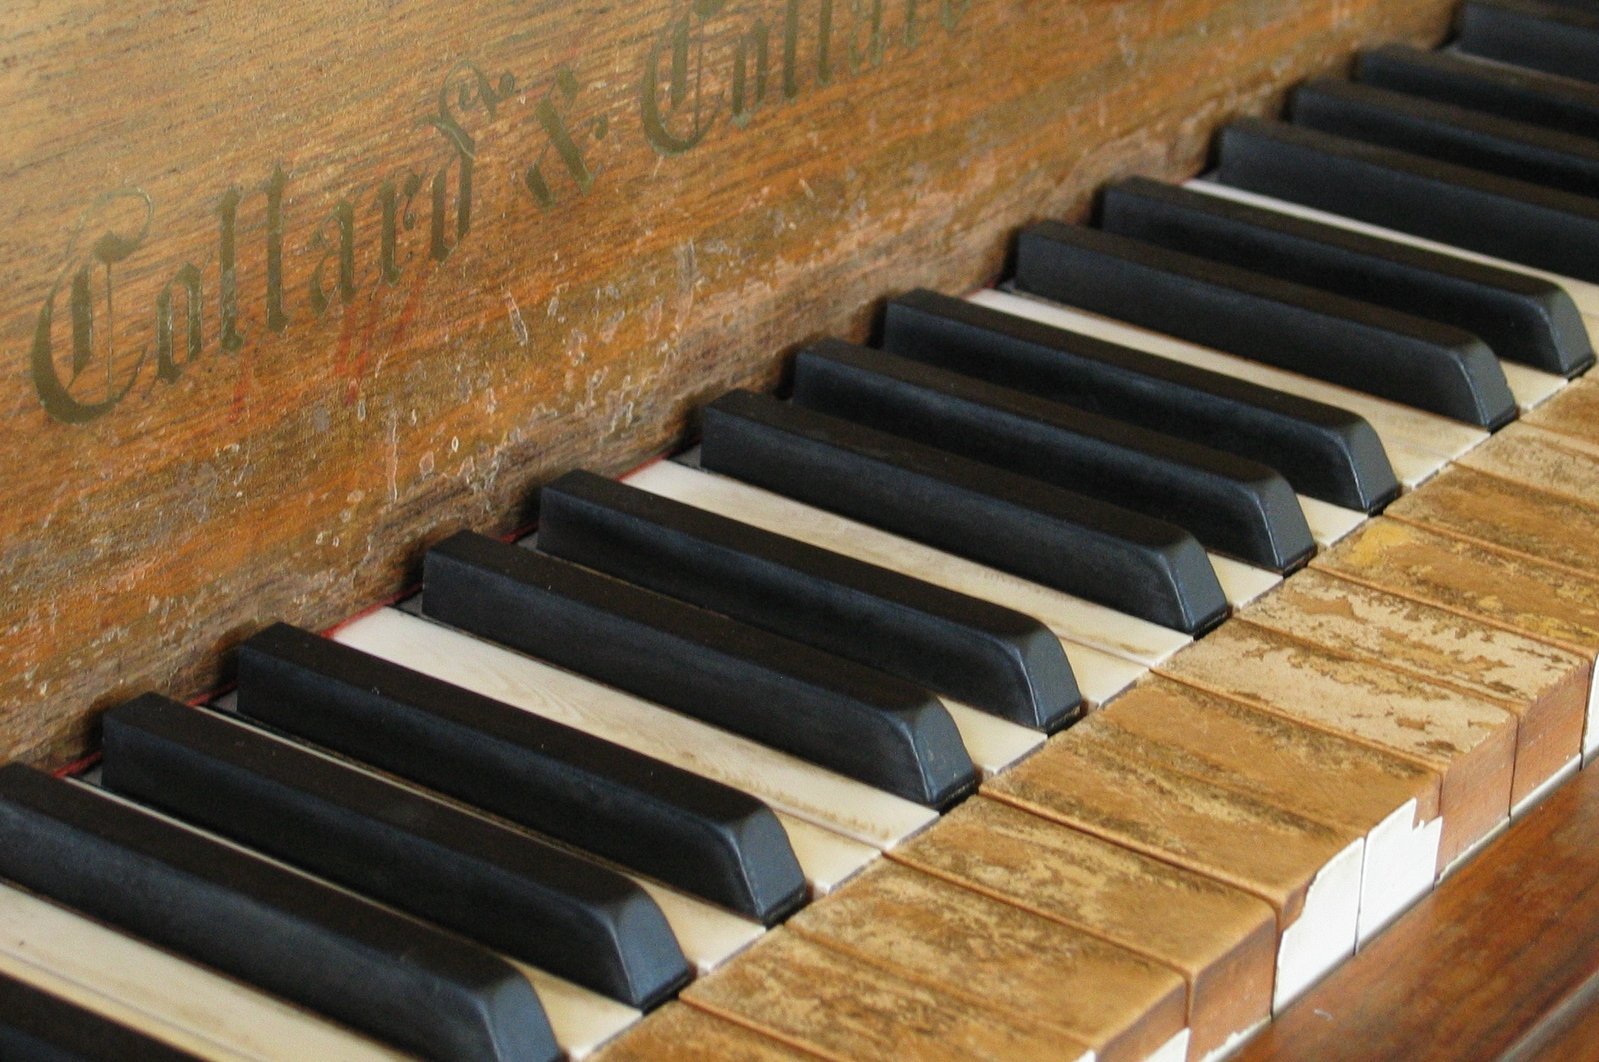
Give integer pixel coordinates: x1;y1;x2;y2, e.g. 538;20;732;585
683;929;1087;1062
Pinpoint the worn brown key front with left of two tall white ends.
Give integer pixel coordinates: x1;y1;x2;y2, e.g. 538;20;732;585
983;729;1366;1009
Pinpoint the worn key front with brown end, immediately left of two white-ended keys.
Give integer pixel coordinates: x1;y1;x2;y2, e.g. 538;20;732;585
887;797;1276;1059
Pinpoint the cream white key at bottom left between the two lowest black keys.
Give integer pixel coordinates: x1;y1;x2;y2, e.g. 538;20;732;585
0;884;409;1062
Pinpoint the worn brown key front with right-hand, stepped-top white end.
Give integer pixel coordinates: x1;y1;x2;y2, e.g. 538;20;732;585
1078;677;1442;940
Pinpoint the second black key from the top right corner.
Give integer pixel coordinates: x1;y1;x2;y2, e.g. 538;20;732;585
1354;45;1599;138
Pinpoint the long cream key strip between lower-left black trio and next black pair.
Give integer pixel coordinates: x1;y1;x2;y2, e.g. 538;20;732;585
334;608;937;850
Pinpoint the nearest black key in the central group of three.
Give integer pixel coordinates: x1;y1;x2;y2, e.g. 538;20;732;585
700;392;1226;633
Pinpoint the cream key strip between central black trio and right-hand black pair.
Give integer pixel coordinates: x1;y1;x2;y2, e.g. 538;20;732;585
971;289;1487;486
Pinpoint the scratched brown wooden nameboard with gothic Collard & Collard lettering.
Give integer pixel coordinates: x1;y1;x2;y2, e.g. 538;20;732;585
0;0;1453;761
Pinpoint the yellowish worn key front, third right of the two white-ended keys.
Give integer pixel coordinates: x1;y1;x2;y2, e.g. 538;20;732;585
1311;518;1599;760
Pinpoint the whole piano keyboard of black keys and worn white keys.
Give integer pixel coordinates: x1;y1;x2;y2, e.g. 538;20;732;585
0;0;1599;1062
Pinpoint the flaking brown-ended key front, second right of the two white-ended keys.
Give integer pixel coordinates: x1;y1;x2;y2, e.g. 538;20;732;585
1244;569;1591;803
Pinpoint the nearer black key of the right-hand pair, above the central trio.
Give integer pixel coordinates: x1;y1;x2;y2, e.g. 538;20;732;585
1015;222;1516;427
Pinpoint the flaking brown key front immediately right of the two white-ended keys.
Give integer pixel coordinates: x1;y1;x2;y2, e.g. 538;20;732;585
1159;619;1516;867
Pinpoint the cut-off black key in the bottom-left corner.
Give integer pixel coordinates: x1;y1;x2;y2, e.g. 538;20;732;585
0;972;200;1062
